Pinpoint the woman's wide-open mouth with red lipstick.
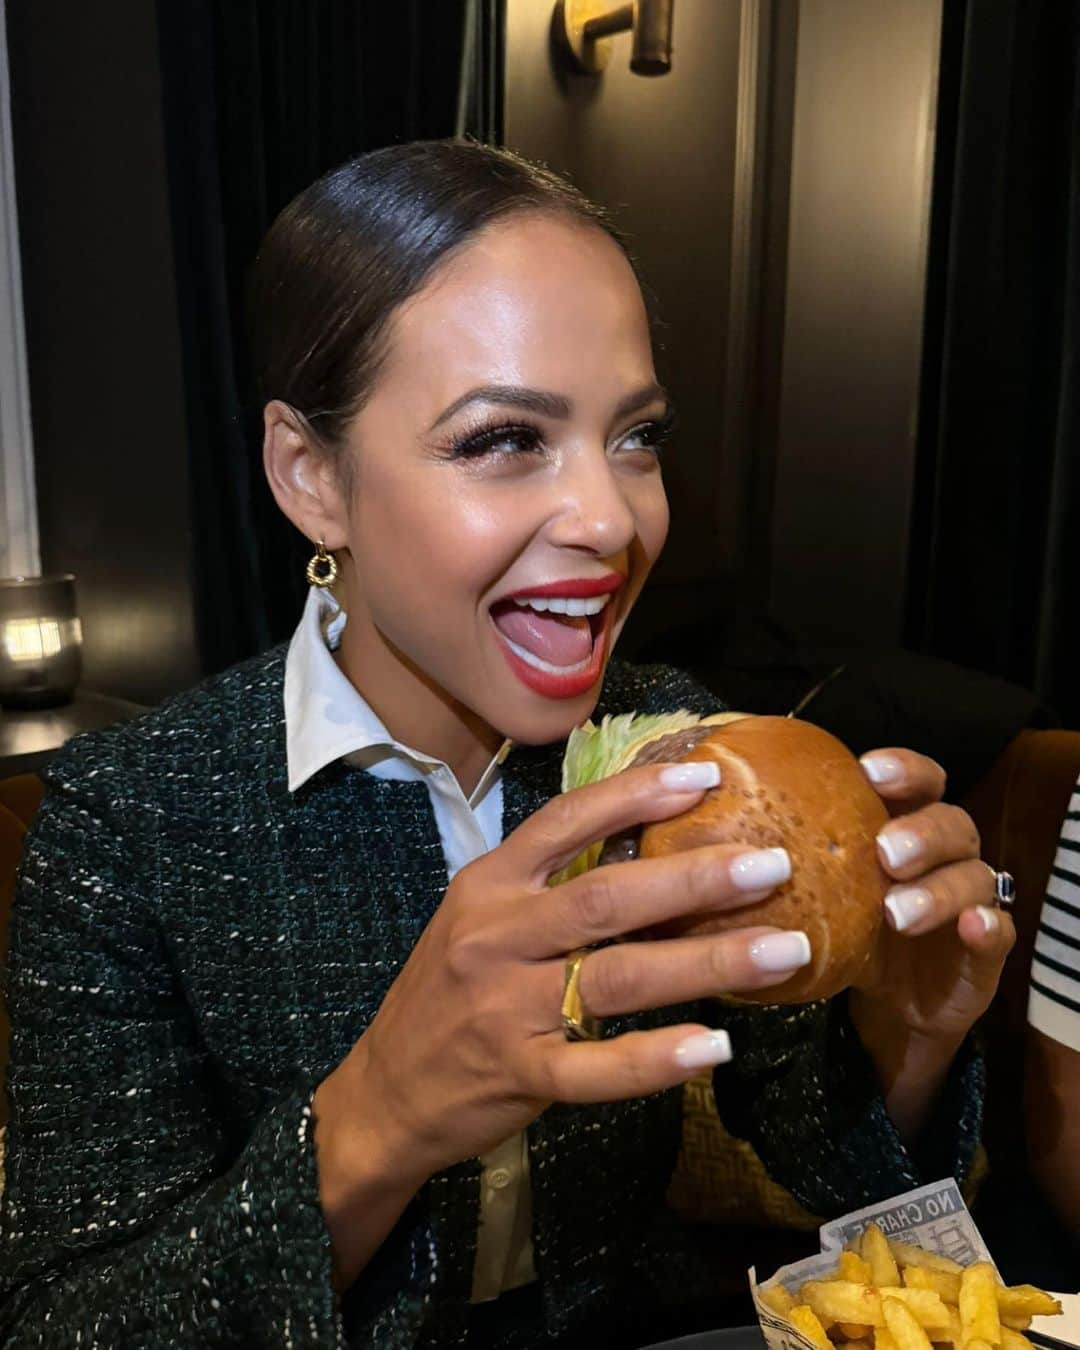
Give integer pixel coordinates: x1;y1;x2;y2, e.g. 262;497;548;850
490;589;614;698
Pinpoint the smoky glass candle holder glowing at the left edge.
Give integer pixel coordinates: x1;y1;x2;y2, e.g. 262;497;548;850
0;574;82;709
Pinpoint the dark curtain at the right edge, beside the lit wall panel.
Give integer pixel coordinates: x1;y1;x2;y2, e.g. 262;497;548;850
909;0;1080;725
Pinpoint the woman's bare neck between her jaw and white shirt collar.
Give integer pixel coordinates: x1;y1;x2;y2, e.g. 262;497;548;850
333;618;504;797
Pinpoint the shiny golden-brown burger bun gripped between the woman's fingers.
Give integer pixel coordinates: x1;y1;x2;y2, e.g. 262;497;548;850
640;717;890;1003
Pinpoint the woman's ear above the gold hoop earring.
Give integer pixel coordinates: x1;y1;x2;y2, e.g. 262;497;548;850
262;398;348;551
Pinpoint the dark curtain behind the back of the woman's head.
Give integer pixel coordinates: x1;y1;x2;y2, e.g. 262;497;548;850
157;0;500;672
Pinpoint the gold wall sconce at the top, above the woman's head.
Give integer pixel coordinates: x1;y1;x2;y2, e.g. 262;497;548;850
552;0;675;76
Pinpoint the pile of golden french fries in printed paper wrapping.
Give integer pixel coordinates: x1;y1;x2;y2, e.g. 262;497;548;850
760;1223;1061;1350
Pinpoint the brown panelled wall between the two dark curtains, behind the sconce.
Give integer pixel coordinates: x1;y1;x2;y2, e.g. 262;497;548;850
505;0;941;655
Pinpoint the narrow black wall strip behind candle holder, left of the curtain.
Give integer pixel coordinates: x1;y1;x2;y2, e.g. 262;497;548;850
7;0;200;703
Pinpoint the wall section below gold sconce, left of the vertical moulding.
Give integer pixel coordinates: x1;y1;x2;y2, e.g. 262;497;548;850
504;0;743;652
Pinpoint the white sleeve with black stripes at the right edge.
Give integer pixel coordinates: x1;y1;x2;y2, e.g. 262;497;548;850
1027;782;1080;1050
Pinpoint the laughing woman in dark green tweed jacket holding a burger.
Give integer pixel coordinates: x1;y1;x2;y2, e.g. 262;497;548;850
3;143;1011;1346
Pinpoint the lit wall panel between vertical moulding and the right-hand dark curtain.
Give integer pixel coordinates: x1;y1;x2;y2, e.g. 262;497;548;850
772;0;942;647
